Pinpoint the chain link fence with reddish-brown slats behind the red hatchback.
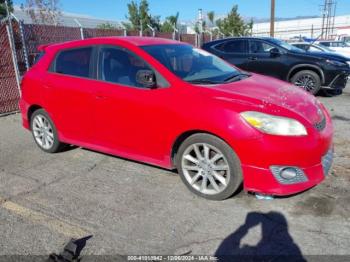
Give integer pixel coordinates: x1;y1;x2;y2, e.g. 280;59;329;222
0;20;218;115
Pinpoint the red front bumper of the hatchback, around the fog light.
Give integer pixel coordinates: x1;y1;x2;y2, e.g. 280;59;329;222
240;110;333;196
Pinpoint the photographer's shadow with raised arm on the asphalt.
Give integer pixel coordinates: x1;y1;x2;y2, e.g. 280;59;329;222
215;211;306;261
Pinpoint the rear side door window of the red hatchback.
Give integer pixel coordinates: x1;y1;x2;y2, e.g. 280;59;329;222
51;47;92;77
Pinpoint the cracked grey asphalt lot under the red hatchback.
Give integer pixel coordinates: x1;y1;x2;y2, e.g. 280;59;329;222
0;83;350;259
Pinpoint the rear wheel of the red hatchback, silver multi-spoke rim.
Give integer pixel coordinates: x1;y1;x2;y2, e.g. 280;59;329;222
30;109;64;153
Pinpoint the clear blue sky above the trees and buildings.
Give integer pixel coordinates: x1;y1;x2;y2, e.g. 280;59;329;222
13;0;350;20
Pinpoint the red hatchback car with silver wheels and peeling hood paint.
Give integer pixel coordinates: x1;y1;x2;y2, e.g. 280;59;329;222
20;37;333;200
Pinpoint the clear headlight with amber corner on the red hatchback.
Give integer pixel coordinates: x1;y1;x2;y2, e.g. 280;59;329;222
240;111;307;136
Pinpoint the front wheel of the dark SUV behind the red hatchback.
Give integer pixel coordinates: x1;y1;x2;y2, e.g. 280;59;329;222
291;70;321;95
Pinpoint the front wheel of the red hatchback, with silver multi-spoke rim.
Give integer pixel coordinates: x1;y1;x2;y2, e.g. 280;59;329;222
176;134;243;200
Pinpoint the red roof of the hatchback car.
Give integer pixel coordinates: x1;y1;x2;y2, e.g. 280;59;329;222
38;36;183;50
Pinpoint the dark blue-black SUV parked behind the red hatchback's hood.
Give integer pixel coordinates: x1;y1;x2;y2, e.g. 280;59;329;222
202;37;350;94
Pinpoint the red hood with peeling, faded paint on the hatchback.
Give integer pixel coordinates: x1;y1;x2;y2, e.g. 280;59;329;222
206;74;324;124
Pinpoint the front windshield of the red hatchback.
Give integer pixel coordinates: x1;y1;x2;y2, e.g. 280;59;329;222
141;44;244;84
